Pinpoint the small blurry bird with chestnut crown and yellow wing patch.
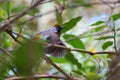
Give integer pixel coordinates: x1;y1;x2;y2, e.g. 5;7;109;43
34;24;66;57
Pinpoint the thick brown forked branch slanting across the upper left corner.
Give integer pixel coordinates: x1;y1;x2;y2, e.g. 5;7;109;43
0;0;41;44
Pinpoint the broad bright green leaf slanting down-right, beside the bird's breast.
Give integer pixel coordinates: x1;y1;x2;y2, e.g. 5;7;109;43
63;34;85;49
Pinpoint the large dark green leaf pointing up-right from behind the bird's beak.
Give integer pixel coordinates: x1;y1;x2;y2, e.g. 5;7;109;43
61;16;82;33
